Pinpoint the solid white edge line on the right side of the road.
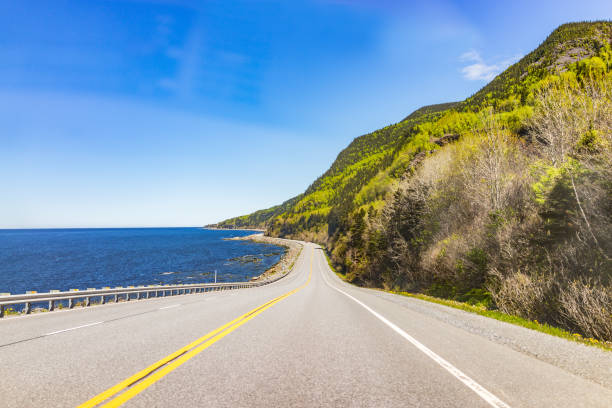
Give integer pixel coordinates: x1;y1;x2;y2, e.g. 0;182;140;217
319;252;510;408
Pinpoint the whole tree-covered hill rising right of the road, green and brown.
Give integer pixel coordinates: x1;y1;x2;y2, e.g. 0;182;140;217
219;21;612;340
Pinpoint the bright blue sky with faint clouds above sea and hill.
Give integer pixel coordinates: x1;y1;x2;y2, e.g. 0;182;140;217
0;0;612;228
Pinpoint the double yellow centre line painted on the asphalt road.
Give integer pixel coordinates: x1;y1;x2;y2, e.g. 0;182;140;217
78;247;314;408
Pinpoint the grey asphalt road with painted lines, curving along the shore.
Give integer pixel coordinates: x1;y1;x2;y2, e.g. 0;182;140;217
0;244;612;408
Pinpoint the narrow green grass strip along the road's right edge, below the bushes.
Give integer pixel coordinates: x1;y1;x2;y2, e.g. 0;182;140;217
323;250;612;351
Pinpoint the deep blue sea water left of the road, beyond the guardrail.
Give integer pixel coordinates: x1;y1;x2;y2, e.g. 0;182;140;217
0;228;284;294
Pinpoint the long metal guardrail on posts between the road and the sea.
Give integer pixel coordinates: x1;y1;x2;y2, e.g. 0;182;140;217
0;272;288;318
